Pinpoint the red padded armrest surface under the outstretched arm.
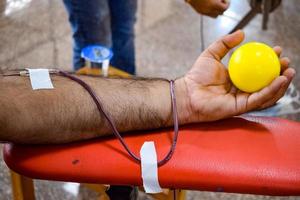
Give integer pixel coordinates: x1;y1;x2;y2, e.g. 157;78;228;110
3;117;300;195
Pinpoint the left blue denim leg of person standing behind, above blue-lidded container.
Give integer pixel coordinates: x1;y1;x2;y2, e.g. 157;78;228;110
63;0;111;70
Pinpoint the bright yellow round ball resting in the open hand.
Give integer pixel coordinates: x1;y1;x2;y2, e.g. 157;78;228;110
228;42;280;93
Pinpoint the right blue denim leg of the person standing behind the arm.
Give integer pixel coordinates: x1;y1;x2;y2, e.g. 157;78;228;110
109;0;137;74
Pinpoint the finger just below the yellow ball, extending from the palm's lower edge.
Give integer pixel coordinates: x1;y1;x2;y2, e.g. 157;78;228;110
247;76;288;111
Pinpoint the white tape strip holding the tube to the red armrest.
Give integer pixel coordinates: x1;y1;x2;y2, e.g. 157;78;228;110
140;141;162;193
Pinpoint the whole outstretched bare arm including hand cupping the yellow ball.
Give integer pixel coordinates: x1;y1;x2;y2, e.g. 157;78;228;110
0;31;295;143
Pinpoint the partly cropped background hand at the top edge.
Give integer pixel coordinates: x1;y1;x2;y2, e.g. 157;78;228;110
186;0;229;17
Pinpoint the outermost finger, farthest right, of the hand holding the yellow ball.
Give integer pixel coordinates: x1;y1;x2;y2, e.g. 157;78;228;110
260;68;296;109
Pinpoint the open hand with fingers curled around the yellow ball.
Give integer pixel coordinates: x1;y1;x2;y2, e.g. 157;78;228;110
178;31;295;122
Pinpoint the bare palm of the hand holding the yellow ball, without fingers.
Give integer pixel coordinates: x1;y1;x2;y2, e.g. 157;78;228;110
185;56;249;121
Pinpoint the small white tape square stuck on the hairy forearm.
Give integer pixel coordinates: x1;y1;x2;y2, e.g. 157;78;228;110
27;69;53;90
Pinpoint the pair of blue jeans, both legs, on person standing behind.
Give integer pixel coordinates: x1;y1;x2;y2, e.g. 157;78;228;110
63;0;137;74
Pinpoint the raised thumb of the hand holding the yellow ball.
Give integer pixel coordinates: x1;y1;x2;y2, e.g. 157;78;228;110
201;30;244;61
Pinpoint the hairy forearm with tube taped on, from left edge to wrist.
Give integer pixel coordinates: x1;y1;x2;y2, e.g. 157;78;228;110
0;75;187;143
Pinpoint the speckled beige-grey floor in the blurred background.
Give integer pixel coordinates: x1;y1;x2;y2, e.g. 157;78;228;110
0;0;300;200
